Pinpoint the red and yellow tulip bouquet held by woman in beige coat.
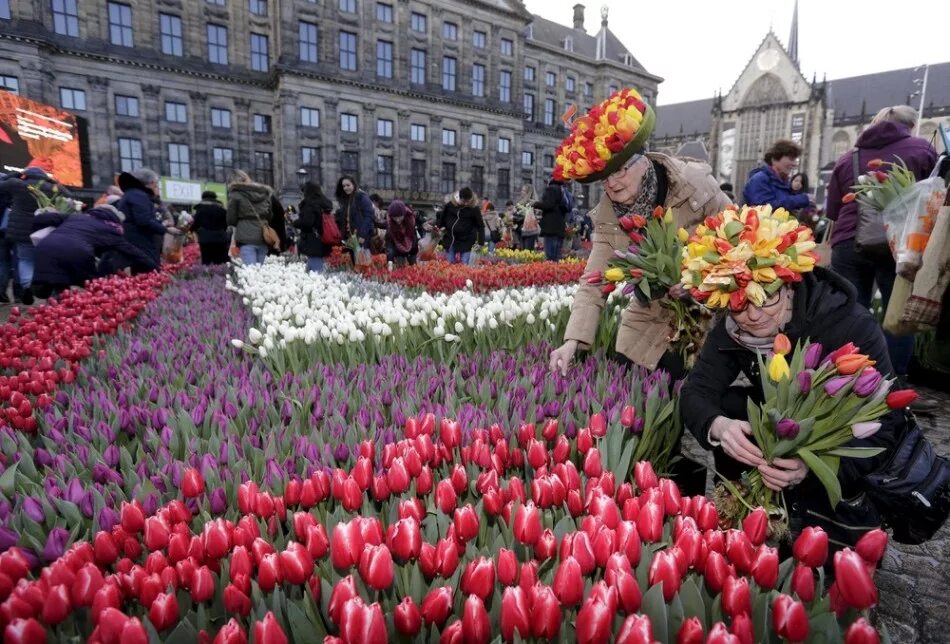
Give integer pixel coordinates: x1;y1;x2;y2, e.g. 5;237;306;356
587;207;708;364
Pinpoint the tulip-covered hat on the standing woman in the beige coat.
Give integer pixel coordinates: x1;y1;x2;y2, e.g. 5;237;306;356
552;88;656;183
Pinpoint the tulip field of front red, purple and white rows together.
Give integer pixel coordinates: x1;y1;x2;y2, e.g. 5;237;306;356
0;255;886;643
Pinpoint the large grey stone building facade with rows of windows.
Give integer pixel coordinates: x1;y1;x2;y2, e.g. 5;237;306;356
0;0;661;203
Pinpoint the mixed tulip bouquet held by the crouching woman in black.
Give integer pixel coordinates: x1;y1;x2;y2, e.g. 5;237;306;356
718;333;916;538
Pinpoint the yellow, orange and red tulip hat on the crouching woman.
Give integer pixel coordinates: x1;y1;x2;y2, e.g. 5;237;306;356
682;206;818;310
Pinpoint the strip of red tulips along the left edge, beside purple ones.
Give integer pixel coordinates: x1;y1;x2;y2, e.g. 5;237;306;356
0;253;194;433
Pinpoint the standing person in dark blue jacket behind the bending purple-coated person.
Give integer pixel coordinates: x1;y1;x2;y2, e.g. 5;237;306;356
116;168;177;273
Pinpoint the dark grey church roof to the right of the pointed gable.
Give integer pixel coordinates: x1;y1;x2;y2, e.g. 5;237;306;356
828;62;950;124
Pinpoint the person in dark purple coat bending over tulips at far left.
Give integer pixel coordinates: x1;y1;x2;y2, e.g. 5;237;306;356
33;205;158;298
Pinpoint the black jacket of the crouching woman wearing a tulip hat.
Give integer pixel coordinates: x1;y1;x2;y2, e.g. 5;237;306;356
680;268;905;539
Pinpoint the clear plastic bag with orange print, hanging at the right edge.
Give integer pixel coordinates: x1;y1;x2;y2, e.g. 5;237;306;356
882;176;947;280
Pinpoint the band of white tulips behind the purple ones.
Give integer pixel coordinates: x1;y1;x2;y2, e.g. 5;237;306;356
228;262;624;373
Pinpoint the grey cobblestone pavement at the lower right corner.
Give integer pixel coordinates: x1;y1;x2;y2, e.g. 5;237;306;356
683;390;950;644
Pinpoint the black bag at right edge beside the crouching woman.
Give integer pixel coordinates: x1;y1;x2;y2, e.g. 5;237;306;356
866;412;950;544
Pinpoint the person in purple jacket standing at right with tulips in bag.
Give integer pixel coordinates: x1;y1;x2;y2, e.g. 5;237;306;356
827;105;937;413
